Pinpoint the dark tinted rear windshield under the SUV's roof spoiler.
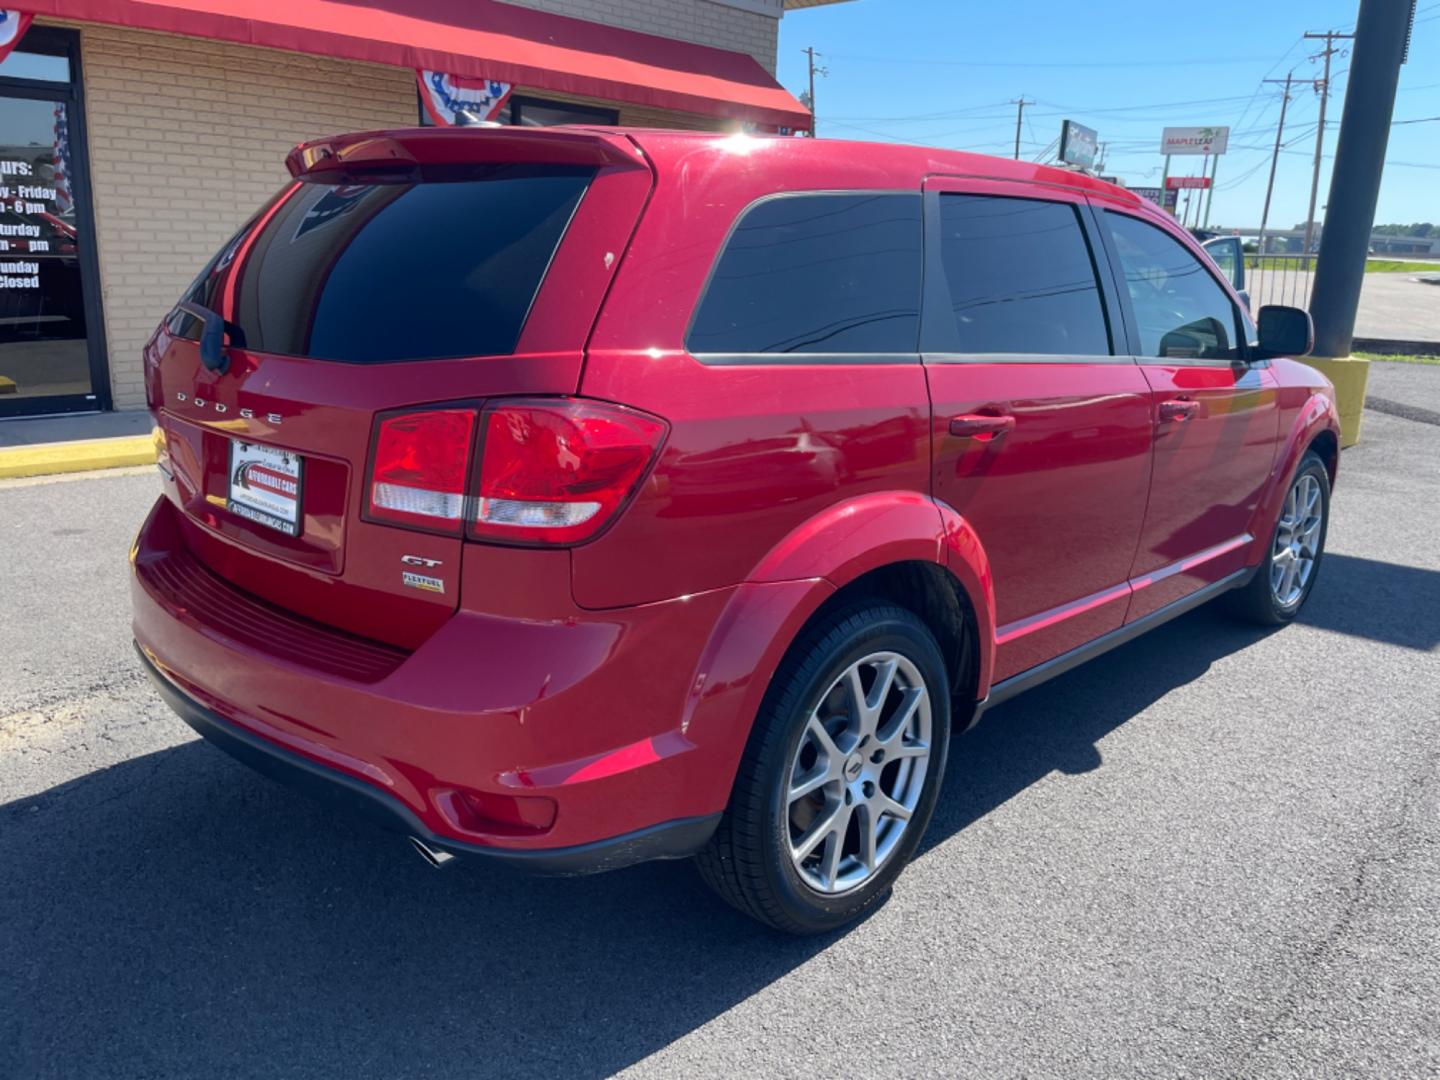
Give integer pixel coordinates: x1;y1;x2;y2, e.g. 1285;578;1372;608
171;166;595;364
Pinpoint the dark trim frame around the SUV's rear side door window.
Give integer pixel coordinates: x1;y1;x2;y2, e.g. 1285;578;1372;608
920;185;1135;364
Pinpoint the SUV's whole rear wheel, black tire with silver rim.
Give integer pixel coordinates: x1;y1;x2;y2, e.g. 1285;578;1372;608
696;602;950;935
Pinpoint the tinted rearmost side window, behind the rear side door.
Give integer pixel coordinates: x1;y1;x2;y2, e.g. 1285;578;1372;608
685;194;922;360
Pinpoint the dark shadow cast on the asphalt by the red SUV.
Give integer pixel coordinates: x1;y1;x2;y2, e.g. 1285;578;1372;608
0;598;1296;1077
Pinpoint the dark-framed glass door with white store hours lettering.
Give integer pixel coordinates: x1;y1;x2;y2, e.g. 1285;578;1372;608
0;27;109;416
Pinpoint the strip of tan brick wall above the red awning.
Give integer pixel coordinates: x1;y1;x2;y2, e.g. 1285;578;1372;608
504;0;780;75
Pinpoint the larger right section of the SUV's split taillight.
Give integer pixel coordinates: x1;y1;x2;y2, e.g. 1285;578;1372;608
469;399;665;544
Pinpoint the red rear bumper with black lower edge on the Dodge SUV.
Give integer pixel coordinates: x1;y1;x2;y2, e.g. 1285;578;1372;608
131;498;828;873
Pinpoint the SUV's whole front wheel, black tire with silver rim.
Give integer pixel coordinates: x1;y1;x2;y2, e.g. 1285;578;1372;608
1228;451;1331;626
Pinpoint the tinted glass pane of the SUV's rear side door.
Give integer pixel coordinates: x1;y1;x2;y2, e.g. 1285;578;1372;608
940;193;1110;356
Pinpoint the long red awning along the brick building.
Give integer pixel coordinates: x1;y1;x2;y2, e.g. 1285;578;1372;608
30;0;809;128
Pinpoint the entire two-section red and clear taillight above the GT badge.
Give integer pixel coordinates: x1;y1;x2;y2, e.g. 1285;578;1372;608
366;397;665;544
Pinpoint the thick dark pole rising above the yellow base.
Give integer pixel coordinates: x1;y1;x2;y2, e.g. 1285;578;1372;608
1310;0;1416;357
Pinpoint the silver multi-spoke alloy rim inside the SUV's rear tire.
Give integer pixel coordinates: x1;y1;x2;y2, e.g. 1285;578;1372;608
785;652;932;894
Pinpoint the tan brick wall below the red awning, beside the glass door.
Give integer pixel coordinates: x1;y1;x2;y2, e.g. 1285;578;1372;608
81;26;416;409
